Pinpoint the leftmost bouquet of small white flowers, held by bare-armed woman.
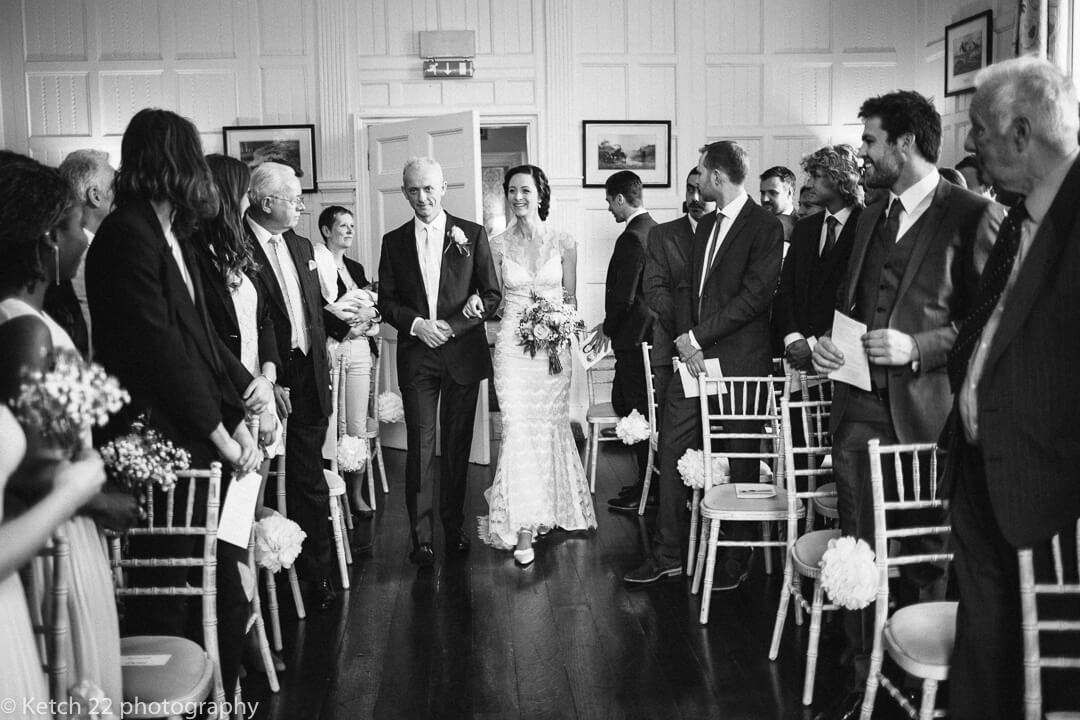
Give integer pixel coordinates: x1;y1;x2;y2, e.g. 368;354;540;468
12;350;131;453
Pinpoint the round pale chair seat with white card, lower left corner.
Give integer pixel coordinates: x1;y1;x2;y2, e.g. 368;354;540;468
120;635;214;718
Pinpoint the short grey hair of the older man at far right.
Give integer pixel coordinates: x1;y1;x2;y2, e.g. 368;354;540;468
972;55;1080;153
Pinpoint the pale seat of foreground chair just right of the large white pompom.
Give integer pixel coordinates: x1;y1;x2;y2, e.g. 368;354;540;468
883;602;957;680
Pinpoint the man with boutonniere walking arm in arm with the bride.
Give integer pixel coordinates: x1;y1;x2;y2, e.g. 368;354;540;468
379;158;501;567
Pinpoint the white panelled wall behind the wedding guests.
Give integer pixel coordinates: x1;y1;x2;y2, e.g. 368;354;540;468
0;0;1015;418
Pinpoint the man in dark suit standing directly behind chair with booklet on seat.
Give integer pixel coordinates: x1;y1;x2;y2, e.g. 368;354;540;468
623;140;783;589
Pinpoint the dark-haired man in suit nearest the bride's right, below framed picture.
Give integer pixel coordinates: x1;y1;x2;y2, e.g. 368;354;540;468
594;171;657;512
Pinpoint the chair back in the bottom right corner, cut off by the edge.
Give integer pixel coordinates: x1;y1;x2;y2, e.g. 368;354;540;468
1016;520;1080;720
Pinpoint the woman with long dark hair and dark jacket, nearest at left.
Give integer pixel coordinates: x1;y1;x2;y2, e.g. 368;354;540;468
86;109;265;693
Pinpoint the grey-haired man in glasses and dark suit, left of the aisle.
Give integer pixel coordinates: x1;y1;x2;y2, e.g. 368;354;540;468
244;163;337;612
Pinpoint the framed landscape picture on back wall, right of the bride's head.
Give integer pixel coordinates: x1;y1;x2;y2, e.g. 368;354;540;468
581;120;672;188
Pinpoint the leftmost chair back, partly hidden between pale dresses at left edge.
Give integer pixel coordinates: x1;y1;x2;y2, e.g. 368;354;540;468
23;525;72;717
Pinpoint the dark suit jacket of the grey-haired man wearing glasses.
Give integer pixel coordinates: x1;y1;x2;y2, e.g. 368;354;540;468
244;220;333;418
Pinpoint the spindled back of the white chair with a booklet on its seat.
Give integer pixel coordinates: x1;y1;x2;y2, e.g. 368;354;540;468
691;373;784;491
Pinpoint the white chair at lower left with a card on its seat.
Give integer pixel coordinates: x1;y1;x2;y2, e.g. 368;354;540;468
111;462;224;718
